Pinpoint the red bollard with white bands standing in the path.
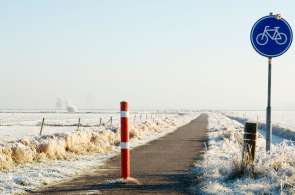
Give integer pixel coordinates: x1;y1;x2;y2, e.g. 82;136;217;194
120;101;130;180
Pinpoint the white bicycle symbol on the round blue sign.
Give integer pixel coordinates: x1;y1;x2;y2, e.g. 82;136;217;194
256;26;288;45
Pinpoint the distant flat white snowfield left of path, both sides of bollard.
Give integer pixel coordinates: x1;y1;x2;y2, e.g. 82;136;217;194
0;111;176;144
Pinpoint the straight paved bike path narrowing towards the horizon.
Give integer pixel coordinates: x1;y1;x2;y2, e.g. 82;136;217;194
32;114;208;195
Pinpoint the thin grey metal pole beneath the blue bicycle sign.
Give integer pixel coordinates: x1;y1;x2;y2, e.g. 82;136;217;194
266;57;272;152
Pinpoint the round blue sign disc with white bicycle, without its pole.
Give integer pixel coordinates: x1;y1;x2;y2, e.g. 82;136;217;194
251;15;293;57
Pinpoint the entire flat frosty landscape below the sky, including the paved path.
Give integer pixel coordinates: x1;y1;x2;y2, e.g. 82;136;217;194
0;111;295;194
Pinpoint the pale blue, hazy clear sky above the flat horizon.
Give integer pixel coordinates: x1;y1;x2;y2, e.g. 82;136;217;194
0;0;295;109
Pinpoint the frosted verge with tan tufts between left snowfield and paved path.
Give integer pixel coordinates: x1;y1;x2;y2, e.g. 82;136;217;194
0;113;198;194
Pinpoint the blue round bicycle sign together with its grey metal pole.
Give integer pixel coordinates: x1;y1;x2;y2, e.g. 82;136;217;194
250;13;293;151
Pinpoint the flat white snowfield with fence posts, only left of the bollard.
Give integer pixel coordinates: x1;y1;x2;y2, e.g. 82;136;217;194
0;112;119;143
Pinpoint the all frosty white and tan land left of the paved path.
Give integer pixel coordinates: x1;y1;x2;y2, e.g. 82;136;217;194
0;112;198;194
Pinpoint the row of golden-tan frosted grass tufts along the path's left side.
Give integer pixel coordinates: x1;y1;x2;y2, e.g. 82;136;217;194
0;118;180;170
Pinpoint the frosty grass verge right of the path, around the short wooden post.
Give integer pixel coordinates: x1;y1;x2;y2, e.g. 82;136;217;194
194;113;295;194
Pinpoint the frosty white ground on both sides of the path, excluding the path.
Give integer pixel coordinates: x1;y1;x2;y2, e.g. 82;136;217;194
0;111;295;194
